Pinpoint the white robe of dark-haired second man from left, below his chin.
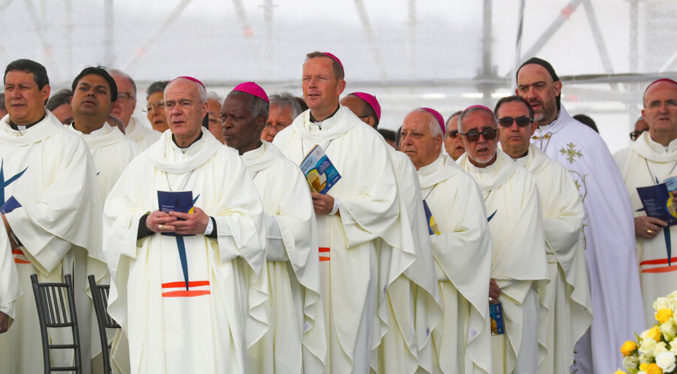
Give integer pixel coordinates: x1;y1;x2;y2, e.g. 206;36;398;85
66;122;142;201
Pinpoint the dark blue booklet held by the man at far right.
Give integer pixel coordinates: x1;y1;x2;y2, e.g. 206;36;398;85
637;178;677;226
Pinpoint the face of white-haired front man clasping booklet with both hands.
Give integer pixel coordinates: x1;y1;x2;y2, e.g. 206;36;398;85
165;79;207;140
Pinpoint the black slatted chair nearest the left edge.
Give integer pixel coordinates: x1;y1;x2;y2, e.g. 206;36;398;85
31;274;82;374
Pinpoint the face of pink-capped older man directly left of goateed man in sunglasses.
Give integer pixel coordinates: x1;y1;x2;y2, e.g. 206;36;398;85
400;110;442;170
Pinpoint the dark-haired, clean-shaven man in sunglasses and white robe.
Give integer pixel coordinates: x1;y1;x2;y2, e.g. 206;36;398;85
494;96;592;374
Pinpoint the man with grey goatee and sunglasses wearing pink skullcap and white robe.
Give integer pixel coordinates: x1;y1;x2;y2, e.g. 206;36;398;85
457;105;548;374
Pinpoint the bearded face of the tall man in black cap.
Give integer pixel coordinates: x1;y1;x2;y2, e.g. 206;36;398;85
515;64;562;125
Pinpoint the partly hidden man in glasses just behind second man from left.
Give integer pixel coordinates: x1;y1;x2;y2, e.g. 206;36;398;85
108;69;161;149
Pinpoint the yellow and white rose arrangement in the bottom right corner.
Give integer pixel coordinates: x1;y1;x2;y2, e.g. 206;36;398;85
615;291;677;374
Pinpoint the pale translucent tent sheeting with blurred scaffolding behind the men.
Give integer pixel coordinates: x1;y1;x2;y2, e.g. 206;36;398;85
0;0;677;152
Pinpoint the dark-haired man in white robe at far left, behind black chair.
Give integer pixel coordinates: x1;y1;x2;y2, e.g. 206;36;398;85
0;60;104;374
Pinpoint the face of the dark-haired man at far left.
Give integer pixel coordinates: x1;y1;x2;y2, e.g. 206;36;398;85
5;70;50;126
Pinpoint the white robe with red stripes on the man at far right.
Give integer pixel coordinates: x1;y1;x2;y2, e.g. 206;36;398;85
615;131;677;326
